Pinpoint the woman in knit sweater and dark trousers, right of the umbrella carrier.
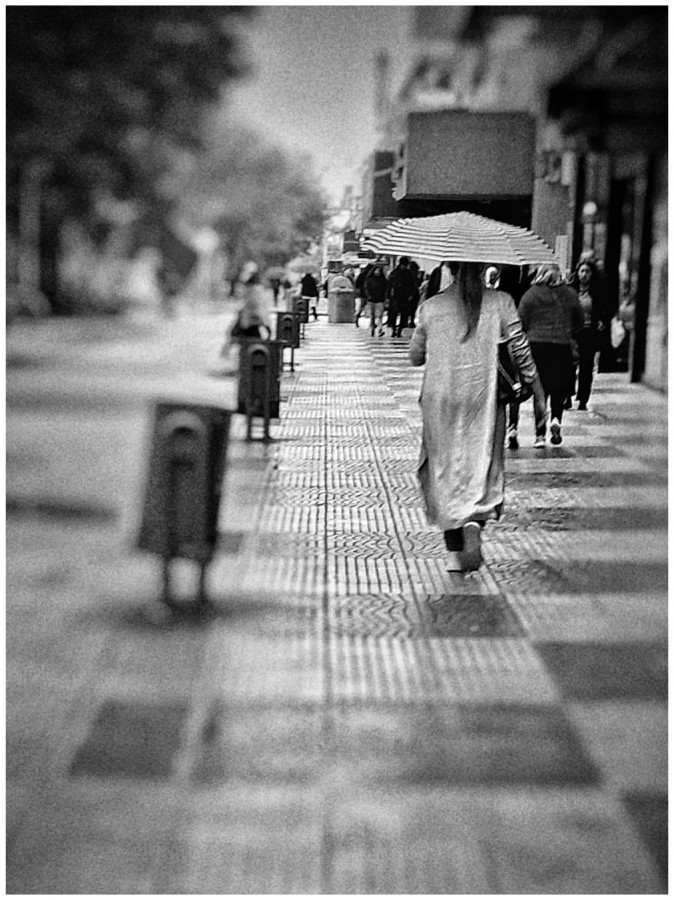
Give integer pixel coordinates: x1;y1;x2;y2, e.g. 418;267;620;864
519;265;583;448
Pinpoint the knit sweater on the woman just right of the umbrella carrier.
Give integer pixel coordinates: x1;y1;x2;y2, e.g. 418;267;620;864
518;284;583;344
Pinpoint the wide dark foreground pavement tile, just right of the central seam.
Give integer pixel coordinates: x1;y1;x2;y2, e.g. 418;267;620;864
326;704;598;786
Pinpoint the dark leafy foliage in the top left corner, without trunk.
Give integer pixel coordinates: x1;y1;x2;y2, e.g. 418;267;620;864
6;6;250;188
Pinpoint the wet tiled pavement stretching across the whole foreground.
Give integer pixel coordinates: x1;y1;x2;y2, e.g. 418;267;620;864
7;312;667;894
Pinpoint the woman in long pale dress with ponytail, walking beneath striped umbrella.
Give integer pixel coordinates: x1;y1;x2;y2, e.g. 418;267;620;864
409;263;542;571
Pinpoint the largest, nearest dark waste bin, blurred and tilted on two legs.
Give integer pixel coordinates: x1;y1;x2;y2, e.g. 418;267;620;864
137;402;231;605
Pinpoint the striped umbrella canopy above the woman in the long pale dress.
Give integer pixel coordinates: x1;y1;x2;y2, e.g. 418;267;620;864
364;212;557;266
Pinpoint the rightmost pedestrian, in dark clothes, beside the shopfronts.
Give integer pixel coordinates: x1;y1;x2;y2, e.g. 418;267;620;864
571;253;609;409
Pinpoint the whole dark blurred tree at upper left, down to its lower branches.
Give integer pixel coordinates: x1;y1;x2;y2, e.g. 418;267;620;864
6;6;255;308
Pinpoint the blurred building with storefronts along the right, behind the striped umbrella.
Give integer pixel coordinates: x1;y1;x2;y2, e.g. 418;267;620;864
361;6;668;389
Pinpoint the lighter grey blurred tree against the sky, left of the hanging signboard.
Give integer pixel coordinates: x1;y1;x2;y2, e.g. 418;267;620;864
174;120;326;284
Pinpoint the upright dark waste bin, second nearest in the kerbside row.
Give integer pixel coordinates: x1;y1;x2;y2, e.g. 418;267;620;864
237;338;285;440
